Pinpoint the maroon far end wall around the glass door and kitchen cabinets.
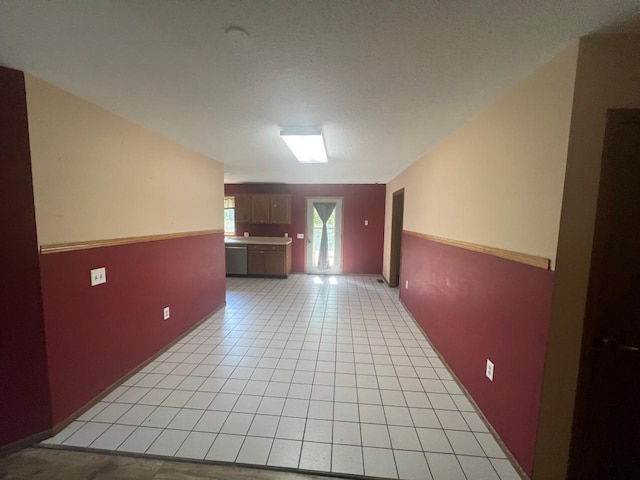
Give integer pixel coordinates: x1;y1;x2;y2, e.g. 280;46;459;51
224;183;386;274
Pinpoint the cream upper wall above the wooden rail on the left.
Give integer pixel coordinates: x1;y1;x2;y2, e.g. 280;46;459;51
25;75;224;245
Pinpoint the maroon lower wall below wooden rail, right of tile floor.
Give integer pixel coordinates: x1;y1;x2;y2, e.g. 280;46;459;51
400;234;554;475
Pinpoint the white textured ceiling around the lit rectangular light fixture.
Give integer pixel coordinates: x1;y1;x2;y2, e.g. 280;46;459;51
0;0;640;183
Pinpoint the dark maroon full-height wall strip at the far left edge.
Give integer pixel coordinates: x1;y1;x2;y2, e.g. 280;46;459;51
0;67;51;446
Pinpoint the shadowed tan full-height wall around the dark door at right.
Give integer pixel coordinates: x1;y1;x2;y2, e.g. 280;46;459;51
534;36;640;480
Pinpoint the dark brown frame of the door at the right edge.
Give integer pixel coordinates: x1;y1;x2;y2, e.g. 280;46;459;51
567;109;640;480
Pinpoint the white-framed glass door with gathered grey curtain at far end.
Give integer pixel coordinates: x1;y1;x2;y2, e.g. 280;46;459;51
305;197;342;275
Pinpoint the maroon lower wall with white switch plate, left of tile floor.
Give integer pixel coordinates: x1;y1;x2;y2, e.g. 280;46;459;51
40;233;225;424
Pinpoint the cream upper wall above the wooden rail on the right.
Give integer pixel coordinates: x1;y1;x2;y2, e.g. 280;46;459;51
383;42;578;279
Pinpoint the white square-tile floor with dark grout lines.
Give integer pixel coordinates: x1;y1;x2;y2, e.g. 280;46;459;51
45;275;520;480
